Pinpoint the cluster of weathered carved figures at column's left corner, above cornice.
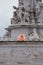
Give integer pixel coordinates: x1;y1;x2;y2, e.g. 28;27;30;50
13;1;29;23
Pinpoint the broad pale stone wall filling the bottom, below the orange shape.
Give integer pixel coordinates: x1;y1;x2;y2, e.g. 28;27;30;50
0;41;43;65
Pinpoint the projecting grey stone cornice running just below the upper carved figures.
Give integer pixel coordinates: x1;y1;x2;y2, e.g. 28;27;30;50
5;23;43;30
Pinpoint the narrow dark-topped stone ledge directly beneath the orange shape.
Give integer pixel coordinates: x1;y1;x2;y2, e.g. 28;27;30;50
0;41;43;45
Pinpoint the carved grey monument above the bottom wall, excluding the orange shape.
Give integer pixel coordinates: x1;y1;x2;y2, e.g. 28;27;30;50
5;0;43;41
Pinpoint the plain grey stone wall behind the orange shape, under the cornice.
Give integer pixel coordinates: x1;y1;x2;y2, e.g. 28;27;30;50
11;27;43;41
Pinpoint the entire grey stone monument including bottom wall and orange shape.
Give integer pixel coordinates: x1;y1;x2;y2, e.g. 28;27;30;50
0;0;43;65
